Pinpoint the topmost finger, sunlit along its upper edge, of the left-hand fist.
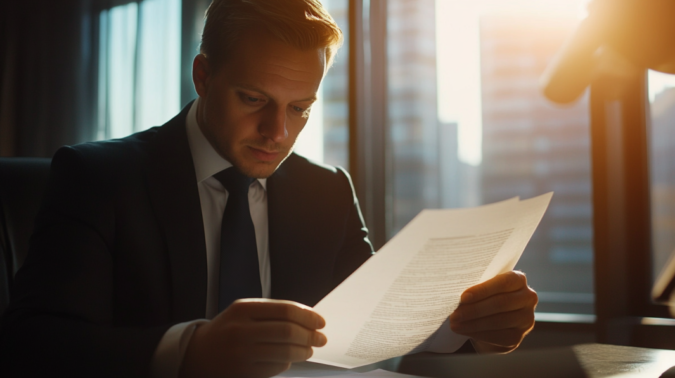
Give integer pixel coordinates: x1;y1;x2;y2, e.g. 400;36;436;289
225;299;326;329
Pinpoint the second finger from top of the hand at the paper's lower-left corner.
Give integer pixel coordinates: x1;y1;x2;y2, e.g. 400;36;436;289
239;320;326;347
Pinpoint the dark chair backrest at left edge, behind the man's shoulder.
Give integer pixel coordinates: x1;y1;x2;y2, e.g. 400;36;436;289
0;158;51;314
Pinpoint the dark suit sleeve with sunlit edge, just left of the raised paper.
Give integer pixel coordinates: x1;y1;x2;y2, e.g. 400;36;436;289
334;168;374;286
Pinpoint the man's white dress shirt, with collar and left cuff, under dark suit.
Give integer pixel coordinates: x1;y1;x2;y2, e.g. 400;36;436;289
152;98;271;378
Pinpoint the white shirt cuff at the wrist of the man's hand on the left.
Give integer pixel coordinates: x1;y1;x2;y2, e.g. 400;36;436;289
151;319;208;378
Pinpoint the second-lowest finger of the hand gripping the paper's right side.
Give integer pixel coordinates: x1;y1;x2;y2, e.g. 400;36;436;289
450;309;534;336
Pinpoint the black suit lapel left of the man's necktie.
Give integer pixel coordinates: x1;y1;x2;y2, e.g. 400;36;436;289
145;103;207;322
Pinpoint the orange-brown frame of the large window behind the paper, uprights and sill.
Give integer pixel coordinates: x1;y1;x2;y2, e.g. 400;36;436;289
348;0;675;348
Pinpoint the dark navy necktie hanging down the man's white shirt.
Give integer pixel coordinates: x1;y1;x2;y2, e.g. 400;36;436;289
213;167;262;311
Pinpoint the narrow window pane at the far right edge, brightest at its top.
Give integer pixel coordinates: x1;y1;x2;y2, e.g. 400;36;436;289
648;71;675;284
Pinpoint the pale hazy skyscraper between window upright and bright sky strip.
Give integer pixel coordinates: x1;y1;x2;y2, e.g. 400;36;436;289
387;0;441;236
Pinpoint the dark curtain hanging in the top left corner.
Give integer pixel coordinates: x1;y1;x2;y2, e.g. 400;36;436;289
0;0;139;157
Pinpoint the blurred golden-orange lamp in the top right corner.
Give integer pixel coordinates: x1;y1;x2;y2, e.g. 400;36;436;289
540;0;675;104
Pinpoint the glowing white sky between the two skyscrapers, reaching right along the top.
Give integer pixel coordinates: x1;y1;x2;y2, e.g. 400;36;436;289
436;0;588;165
